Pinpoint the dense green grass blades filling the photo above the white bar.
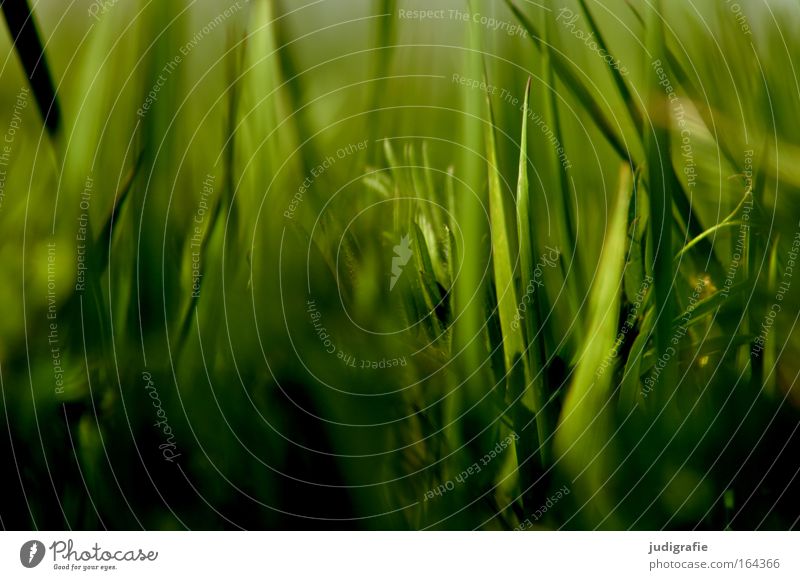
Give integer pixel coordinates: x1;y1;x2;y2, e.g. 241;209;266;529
0;0;800;529
